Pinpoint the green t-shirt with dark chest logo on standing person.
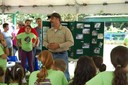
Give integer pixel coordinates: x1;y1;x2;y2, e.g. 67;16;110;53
16;32;36;52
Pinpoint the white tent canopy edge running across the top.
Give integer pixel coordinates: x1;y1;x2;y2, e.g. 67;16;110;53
0;0;128;14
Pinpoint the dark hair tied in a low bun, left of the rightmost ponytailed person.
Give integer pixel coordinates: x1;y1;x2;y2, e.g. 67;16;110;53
92;56;106;72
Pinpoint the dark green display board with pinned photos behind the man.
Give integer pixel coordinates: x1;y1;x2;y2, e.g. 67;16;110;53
43;22;104;59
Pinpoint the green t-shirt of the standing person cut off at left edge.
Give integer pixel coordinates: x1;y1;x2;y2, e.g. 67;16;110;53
0;44;7;70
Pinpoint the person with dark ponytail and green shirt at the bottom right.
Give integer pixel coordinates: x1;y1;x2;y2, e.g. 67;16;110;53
85;46;128;85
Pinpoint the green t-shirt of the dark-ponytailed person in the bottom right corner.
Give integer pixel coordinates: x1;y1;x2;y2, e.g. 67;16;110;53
86;71;114;85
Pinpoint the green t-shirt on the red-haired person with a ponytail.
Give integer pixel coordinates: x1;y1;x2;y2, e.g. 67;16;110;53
29;69;68;85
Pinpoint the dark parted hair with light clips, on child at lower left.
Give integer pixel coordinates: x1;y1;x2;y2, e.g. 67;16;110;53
5;64;24;85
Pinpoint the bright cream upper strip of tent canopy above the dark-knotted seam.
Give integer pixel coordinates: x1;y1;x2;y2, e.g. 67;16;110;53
1;0;124;6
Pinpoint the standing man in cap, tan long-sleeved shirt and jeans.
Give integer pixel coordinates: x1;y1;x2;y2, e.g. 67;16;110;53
44;13;74;80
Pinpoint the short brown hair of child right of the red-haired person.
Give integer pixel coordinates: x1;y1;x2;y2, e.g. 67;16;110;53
53;59;67;72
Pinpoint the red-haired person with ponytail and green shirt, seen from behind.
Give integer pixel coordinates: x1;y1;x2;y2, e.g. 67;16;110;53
29;50;68;85
